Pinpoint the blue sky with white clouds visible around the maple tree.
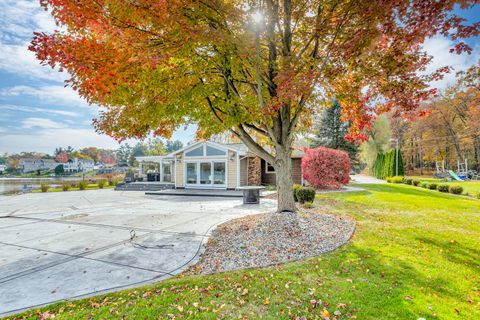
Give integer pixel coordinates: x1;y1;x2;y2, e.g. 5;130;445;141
0;0;480;153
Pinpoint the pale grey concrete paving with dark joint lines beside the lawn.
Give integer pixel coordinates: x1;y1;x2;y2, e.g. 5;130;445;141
0;190;276;316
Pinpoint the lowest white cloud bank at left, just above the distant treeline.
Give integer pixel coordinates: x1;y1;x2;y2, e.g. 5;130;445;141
0;128;119;153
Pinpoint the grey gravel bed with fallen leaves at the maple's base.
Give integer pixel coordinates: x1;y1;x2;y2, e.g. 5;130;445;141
187;211;355;274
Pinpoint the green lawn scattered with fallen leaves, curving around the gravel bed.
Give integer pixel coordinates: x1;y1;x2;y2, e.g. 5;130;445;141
7;184;480;320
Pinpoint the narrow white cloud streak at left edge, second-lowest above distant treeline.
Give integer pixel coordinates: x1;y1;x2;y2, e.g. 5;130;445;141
0;85;89;107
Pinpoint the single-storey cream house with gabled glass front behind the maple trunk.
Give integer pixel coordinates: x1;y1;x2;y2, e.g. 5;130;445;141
136;141;303;189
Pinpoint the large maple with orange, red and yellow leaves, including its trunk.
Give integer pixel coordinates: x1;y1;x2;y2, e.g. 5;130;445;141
30;0;480;211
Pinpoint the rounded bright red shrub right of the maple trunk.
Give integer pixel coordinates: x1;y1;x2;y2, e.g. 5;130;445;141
302;147;350;189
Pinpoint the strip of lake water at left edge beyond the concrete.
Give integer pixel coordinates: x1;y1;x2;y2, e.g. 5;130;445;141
0;177;82;196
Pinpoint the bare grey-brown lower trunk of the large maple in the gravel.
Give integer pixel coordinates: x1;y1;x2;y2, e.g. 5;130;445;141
274;150;297;212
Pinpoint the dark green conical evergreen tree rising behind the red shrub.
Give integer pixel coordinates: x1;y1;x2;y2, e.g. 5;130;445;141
311;100;359;168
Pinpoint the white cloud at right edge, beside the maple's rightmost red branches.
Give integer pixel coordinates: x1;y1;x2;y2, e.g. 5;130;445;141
423;36;480;89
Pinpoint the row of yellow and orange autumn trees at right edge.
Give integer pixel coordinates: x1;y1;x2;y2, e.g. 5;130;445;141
360;62;480;174
